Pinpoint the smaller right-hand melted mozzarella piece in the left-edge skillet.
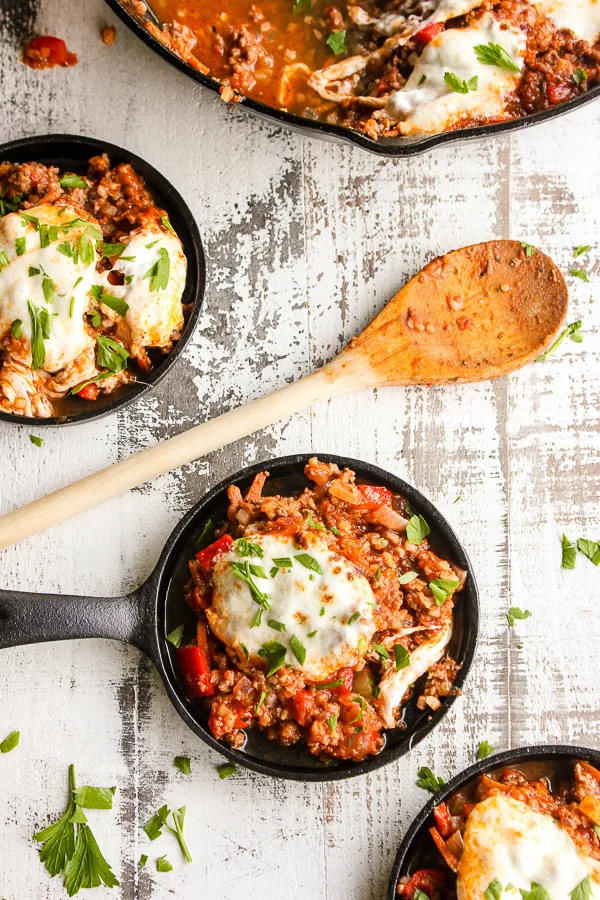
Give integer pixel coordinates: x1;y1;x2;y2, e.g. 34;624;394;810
103;224;187;347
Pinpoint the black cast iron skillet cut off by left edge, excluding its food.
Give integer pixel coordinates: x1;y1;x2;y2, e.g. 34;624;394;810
0;134;206;428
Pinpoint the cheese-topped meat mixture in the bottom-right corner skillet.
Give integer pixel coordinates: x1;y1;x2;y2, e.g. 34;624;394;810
398;761;600;900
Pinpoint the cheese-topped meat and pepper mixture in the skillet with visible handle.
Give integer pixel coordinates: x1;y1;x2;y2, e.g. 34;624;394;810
178;458;466;762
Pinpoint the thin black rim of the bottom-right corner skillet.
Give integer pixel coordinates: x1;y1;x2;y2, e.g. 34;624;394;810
386;744;600;900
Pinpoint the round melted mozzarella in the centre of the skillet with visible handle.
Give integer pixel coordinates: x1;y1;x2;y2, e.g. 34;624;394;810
206;534;375;681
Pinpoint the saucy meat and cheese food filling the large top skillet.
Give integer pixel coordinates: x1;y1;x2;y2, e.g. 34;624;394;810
124;0;600;139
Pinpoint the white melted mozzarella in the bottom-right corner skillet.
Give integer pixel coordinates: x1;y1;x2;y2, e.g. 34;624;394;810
457;793;600;900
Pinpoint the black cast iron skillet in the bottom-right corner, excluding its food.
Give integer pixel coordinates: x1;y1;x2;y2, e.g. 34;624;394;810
387;744;600;900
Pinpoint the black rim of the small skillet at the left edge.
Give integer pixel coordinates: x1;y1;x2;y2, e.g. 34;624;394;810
0;134;206;429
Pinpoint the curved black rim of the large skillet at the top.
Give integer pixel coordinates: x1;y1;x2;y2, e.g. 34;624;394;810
106;0;600;159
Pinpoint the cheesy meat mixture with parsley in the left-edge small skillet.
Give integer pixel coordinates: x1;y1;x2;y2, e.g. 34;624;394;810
0;155;187;418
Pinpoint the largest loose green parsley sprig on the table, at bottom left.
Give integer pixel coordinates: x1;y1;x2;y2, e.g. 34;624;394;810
33;766;119;897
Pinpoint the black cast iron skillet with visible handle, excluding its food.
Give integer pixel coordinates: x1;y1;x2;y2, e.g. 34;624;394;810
0;453;478;781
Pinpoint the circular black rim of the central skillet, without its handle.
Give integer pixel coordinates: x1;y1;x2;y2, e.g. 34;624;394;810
144;451;479;782
